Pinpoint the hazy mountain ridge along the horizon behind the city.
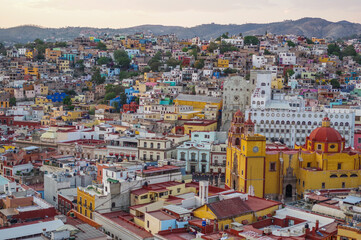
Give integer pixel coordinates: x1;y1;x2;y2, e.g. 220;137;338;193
0;17;361;43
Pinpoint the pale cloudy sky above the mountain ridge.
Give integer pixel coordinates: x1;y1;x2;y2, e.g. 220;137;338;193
0;0;361;28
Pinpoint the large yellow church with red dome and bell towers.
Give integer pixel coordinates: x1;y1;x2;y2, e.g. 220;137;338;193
226;111;361;200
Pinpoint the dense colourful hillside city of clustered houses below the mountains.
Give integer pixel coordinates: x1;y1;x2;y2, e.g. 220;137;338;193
0;33;361;240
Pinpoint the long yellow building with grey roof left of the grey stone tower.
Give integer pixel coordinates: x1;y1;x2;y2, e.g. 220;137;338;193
174;94;222;111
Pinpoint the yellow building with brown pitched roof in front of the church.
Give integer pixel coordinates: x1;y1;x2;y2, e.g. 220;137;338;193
193;196;281;230
